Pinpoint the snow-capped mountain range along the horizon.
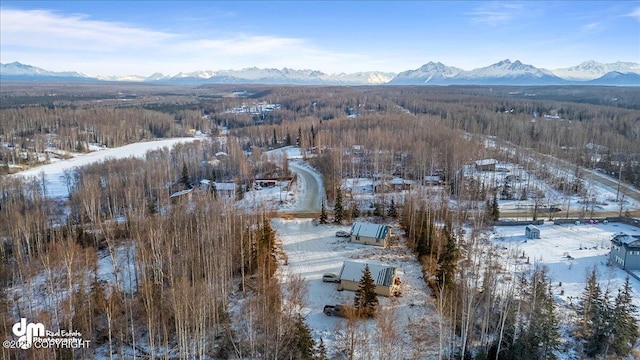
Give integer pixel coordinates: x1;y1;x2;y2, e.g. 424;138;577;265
0;59;640;86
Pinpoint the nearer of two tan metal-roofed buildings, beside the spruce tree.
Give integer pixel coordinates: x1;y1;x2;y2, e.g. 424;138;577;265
338;261;400;297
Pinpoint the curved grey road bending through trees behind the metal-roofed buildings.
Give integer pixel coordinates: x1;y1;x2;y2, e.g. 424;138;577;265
286;161;325;217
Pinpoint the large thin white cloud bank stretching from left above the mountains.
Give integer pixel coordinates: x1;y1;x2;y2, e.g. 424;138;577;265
0;8;372;75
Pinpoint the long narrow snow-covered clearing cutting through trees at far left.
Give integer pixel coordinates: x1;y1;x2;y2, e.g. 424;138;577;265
13;138;202;198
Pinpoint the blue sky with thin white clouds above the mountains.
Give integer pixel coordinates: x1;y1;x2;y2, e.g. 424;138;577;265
0;0;640;76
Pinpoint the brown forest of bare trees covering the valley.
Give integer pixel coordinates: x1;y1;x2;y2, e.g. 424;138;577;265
0;86;640;359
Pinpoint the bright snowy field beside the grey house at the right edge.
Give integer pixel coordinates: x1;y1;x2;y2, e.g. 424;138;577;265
491;222;640;306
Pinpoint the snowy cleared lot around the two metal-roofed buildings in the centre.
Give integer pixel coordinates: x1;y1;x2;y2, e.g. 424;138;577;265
272;219;438;359
